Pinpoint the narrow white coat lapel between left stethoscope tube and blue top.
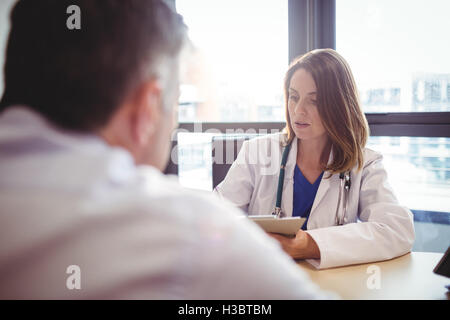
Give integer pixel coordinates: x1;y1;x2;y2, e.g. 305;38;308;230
281;138;297;217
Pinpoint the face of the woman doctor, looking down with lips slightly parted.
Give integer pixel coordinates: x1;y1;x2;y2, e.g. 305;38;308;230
288;69;327;140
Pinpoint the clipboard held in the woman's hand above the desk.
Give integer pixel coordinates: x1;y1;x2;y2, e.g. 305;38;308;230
248;214;306;236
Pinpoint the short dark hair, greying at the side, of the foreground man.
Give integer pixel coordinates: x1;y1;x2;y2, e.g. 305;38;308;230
0;0;186;131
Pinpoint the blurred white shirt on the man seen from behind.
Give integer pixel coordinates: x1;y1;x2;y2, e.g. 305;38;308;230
0;107;330;299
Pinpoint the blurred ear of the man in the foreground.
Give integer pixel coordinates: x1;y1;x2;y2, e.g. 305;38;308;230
130;79;162;146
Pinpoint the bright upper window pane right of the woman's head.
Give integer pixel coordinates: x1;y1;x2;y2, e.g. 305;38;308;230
336;0;450;112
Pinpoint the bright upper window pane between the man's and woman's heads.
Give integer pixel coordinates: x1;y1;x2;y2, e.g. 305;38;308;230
176;0;288;122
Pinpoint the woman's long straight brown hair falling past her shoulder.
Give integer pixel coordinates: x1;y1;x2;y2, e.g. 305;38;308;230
284;49;369;174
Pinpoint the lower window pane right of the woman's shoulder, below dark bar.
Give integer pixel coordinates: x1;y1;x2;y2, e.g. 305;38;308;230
367;137;450;212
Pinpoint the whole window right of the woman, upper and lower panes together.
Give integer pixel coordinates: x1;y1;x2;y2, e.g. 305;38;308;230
336;0;450;252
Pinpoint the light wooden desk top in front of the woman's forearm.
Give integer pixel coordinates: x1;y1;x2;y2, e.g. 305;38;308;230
298;252;450;299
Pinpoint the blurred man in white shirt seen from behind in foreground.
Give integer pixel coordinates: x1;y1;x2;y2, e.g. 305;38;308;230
0;0;327;299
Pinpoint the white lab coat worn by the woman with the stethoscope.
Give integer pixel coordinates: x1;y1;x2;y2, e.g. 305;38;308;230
215;133;414;269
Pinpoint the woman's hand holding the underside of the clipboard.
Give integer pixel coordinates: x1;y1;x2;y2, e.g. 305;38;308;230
268;229;320;259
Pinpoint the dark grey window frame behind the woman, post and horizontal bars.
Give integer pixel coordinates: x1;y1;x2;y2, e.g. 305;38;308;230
165;0;450;174
